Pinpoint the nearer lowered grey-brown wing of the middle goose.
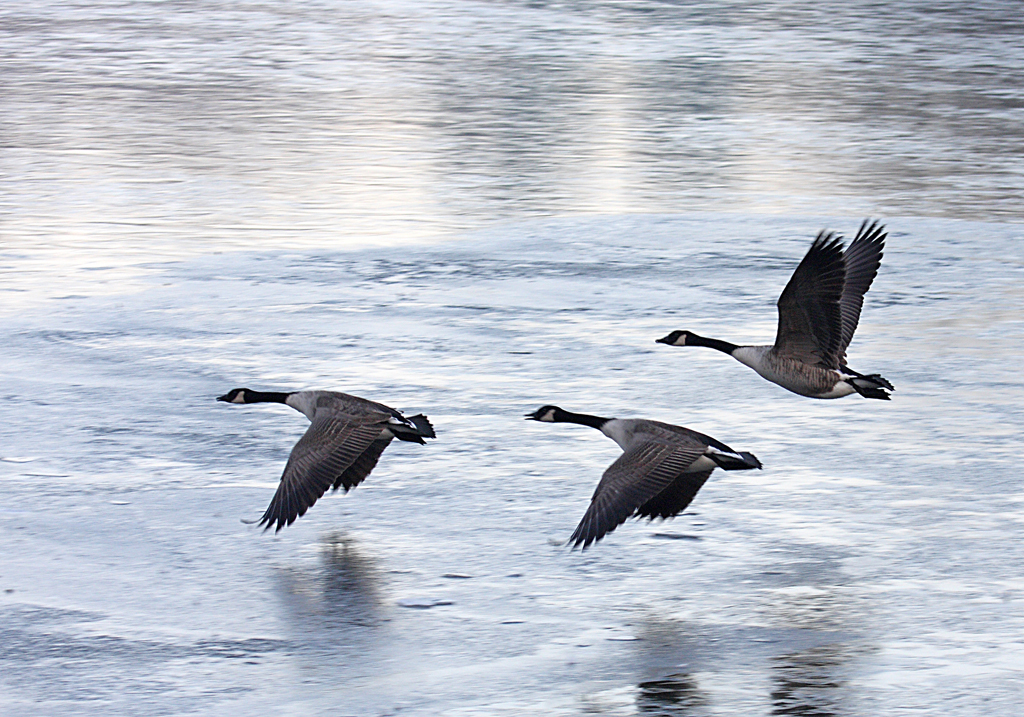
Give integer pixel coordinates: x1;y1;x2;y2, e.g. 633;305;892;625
569;439;707;549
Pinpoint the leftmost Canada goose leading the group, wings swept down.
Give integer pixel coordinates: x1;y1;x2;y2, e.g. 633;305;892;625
217;388;434;531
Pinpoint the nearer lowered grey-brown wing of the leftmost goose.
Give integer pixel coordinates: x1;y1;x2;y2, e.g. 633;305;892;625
259;412;388;531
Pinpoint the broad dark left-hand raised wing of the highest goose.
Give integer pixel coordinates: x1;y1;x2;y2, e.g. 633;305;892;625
774;231;846;369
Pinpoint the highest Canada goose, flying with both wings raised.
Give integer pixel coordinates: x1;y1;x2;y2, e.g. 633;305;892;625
657;220;894;400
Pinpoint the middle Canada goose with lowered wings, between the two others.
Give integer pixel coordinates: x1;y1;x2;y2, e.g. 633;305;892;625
526;406;761;550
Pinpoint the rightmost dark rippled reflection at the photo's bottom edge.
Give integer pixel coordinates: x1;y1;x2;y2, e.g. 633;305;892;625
771;644;850;717
